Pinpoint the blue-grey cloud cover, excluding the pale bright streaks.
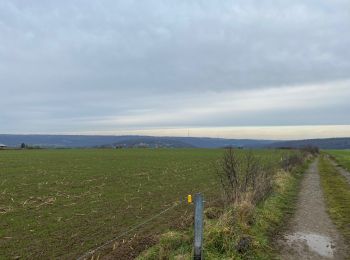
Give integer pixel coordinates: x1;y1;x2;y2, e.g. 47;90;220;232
0;0;350;132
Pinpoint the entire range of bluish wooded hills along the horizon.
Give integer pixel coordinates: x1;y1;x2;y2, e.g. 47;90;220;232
0;134;350;149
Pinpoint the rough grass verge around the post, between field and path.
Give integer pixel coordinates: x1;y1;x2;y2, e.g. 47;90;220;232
137;163;307;260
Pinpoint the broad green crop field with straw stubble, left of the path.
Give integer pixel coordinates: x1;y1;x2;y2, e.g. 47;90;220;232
0;149;282;259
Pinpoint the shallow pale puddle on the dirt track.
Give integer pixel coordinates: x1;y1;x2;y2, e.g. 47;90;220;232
285;232;333;258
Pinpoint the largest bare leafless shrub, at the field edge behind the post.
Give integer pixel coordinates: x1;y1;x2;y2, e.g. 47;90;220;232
217;148;274;203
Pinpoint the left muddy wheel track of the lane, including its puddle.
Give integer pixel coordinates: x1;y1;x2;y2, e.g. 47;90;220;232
278;160;346;260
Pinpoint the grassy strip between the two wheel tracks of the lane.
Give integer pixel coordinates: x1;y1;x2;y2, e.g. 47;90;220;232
319;157;350;245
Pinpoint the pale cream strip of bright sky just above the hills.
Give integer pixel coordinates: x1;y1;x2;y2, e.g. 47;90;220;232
0;125;350;140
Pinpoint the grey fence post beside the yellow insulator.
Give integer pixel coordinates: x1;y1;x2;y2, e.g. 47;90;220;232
193;193;204;260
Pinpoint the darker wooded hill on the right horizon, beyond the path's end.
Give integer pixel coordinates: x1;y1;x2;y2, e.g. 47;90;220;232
268;137;350;149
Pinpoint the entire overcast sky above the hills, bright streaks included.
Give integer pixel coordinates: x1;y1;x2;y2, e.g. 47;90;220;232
0;0;350;139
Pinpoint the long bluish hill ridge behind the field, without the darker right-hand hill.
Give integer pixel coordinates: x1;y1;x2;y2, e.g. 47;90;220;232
0;134;274;148
